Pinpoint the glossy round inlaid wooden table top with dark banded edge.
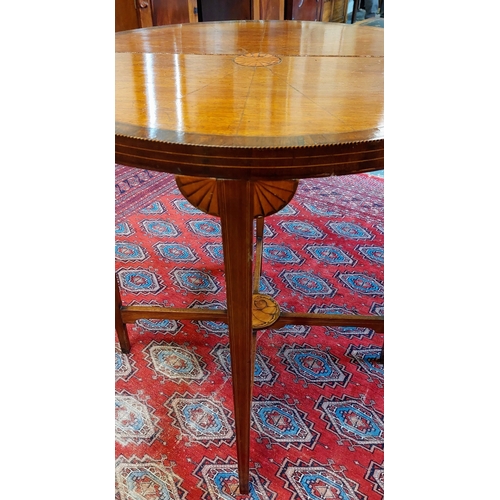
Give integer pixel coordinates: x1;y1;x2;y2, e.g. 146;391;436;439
115;21;384;179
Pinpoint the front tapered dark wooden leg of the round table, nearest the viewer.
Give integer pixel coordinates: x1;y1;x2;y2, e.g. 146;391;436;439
217;180;255;495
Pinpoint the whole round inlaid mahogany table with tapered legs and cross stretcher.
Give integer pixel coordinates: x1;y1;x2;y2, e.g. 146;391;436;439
115;21;384;494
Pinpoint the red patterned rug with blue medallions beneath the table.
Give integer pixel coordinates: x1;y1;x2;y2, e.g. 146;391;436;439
115;166;384;500
